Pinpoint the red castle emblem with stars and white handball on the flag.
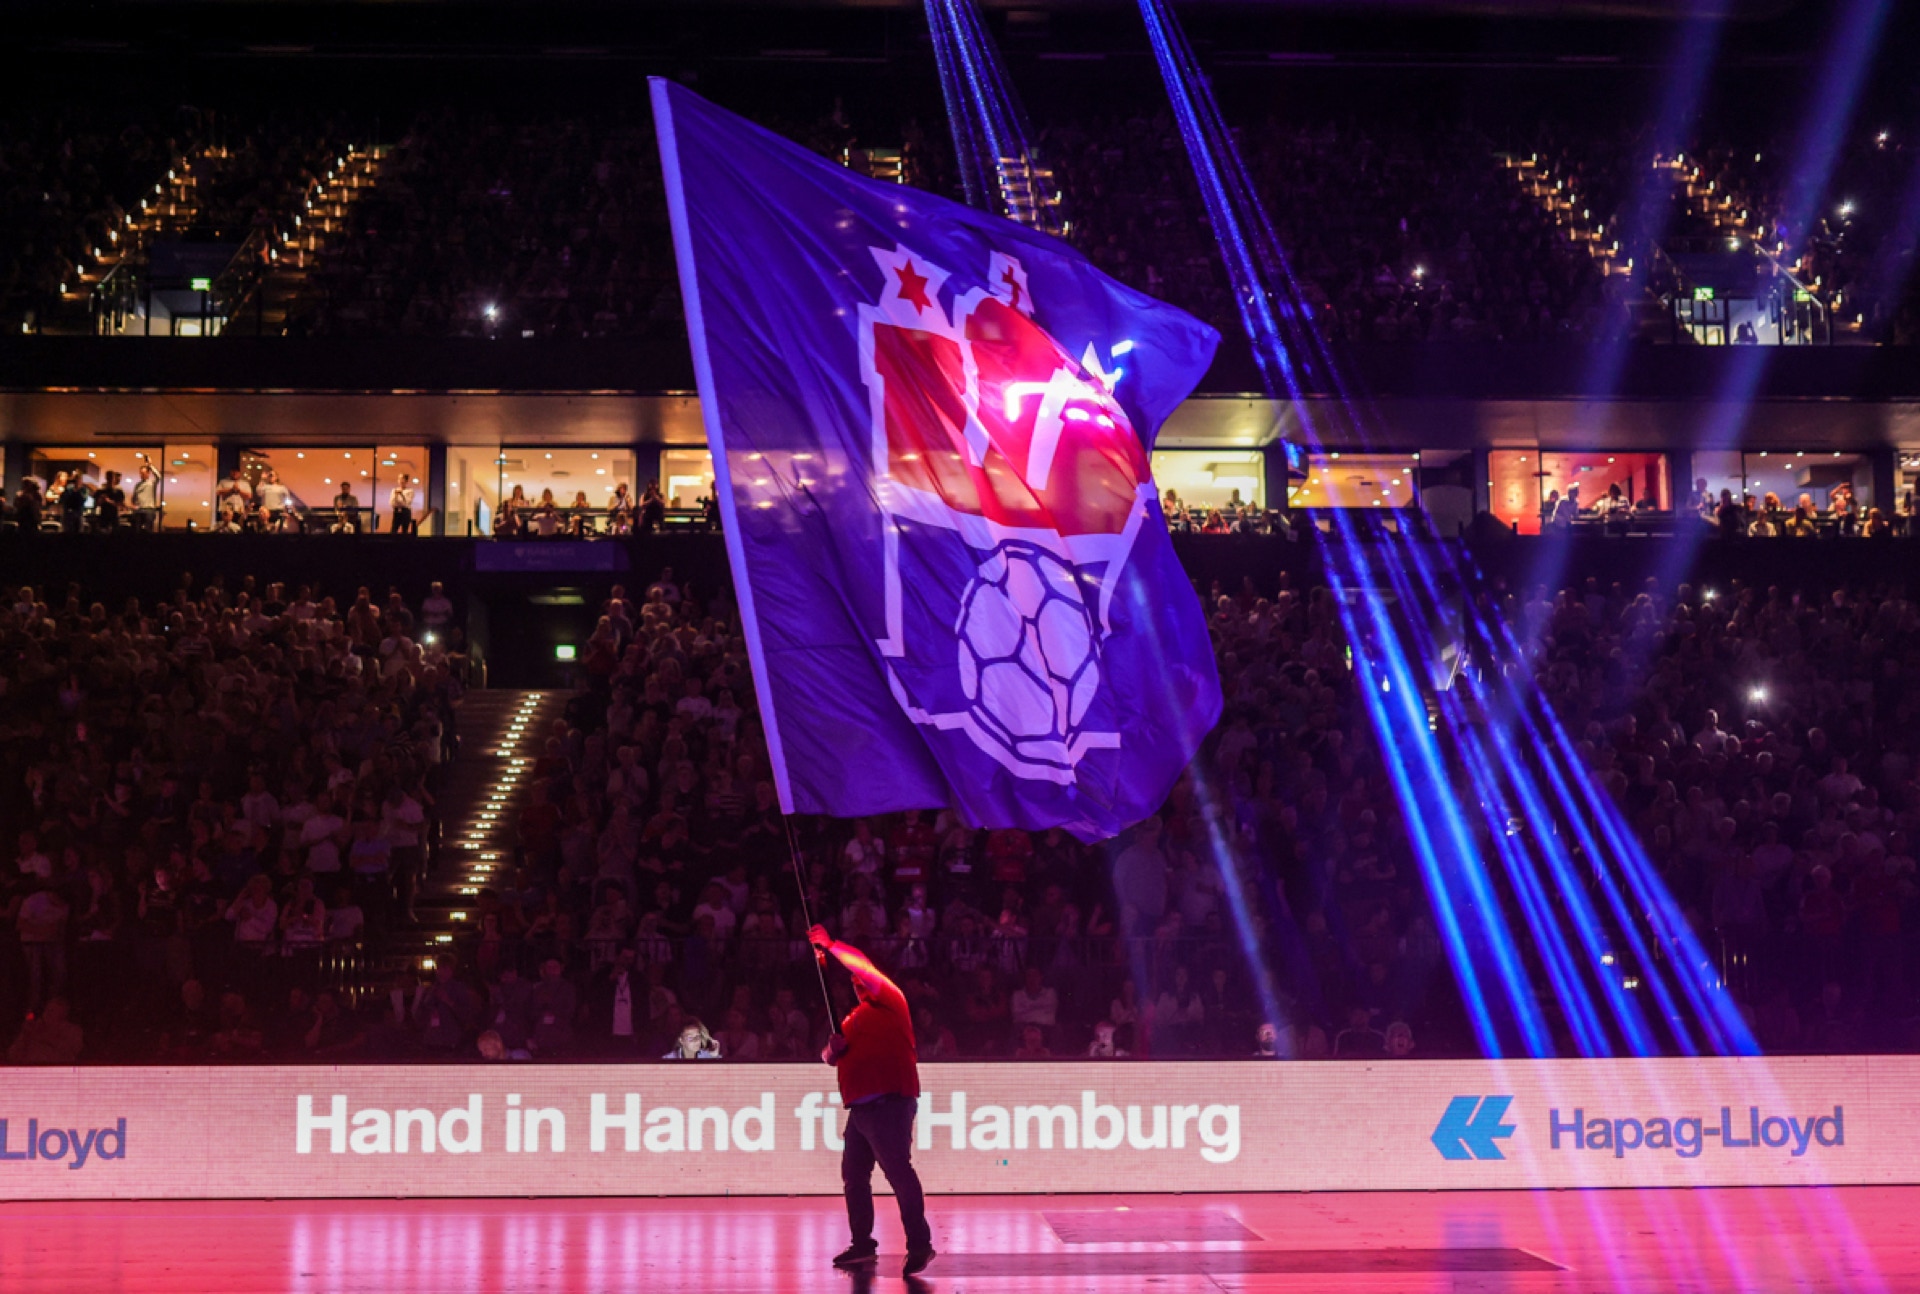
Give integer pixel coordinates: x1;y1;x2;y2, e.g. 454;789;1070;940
860;246;1156;783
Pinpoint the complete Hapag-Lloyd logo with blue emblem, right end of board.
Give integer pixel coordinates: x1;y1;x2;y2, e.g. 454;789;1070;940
1428;1096;1847;1160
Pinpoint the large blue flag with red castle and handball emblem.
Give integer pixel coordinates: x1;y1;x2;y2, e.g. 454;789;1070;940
653;81;1219;841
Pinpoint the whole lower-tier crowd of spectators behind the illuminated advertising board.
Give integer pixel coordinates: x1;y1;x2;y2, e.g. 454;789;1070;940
0;545;1920;1060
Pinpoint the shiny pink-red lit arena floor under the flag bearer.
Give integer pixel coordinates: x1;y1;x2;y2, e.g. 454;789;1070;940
0;1188;1920;1294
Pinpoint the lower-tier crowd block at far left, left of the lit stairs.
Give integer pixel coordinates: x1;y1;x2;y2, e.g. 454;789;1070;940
0;578;461;1060
